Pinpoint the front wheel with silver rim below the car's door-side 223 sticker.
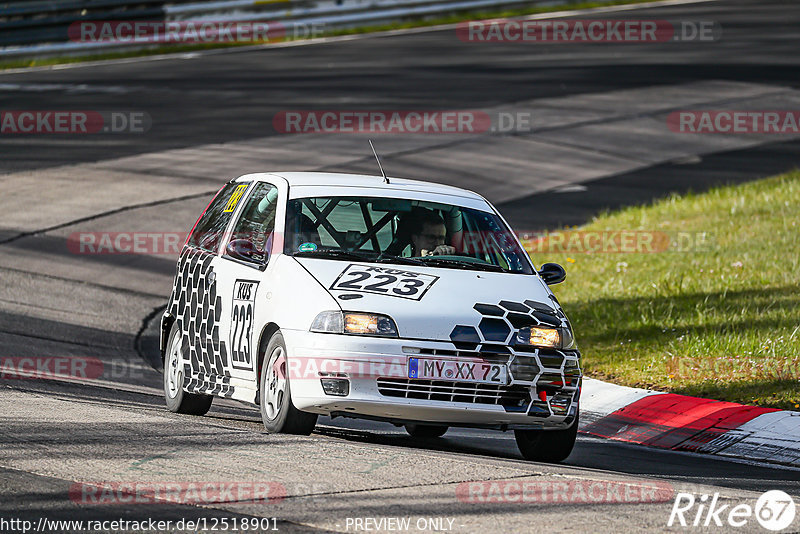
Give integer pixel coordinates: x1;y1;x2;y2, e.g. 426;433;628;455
259;332;317;436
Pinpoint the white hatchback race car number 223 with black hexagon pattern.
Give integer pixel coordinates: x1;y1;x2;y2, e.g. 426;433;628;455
161;172;581;462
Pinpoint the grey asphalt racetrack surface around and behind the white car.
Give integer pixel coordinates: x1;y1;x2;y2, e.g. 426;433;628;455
0;1;800;532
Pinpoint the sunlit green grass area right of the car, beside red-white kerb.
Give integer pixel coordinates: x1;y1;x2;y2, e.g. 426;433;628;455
544;171;800;409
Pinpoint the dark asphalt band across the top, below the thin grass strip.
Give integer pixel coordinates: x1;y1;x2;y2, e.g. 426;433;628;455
0;0;800;168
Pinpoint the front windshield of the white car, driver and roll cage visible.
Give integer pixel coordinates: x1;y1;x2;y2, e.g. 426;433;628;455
284;197;533;274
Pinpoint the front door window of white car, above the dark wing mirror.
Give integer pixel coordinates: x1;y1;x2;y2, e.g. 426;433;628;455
225;182;278;263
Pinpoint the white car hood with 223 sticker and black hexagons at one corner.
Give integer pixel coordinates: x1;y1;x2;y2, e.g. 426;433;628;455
295;258;567;343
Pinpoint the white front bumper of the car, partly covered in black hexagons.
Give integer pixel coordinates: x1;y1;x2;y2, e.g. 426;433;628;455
282;330;581;429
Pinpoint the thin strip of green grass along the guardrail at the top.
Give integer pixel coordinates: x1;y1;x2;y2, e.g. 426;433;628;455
0;0;656;70
